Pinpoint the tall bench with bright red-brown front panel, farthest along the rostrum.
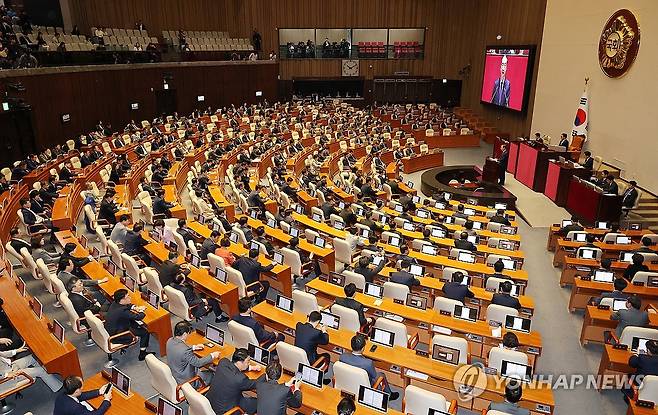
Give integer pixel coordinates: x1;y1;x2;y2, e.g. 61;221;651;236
514;141;564;192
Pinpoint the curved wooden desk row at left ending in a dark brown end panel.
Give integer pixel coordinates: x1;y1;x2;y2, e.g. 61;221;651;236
55;230;172;356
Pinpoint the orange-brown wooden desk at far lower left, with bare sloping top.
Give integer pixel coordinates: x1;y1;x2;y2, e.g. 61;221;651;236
0;276;82;377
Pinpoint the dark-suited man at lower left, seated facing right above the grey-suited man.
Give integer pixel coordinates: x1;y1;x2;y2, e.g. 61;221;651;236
105;288;151;361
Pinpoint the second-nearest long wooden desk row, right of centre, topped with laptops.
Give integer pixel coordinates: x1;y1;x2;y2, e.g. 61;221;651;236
306;278;542;366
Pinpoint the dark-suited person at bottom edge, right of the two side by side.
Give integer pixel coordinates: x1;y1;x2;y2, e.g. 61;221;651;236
256;361;302;415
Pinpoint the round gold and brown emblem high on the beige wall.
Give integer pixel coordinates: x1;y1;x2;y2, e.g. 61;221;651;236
599;9;640;78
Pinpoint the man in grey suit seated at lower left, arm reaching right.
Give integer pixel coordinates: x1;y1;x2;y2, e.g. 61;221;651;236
167;321;219;385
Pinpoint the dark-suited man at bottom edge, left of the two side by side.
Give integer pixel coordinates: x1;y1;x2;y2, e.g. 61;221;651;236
206;348;264;415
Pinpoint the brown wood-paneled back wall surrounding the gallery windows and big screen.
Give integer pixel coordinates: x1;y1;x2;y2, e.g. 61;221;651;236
69;0;546;135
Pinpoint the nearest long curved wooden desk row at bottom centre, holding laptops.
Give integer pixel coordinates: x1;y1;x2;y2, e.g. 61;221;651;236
252;302;555;412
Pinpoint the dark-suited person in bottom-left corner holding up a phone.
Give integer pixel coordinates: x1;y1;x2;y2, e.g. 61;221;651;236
53;376;112;415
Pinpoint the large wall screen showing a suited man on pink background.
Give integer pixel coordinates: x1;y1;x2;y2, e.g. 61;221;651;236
480;46;534;112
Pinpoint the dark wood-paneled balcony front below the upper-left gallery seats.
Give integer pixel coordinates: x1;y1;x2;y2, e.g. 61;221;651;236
0;62;278;149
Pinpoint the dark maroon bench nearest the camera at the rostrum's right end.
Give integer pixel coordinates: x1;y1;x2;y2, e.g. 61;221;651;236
566;177;622;224
